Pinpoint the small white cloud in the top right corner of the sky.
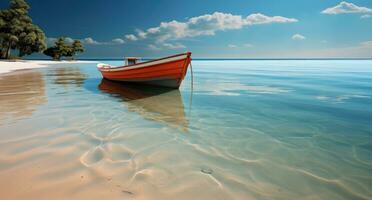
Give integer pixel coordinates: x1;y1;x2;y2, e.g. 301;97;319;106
321;1;372;15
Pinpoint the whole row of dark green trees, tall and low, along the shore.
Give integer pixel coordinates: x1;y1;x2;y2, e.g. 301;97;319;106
0;0;84;60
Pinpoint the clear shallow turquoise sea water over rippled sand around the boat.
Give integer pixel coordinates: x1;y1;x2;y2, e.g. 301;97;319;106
0;60;372;199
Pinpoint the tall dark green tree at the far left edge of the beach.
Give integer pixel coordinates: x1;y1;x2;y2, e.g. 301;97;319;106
0;0;46;58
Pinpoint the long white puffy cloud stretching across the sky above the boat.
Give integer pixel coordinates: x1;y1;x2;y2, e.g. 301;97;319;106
125;12;298;43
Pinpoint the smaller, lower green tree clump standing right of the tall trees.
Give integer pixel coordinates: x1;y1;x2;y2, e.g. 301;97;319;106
44;37;84;60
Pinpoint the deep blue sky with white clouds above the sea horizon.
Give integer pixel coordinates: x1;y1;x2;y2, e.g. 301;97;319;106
0;0;372;58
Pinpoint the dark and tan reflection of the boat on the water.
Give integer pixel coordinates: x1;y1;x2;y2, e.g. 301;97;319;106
98;79;188;131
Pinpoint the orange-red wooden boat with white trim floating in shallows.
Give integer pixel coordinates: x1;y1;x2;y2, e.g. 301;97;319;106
97;52;191;88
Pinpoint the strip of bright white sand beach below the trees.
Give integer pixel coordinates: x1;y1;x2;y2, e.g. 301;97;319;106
0;60;97;76
